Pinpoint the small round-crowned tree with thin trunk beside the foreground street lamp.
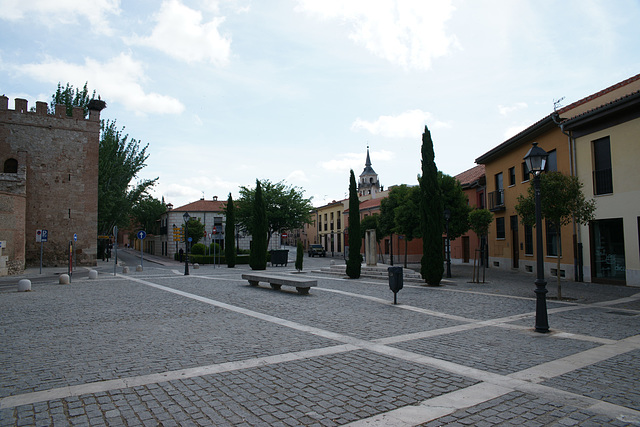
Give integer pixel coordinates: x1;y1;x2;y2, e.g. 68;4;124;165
516;172;596;299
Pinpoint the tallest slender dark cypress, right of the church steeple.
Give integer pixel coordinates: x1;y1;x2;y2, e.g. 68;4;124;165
419;126;444;286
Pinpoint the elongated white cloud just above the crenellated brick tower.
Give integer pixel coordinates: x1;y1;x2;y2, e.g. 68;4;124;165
20;53;184;114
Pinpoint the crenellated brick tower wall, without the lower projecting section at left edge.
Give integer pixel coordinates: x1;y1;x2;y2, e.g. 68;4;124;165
0;97;100;266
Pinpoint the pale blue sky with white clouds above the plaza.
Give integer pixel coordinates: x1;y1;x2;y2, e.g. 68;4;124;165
0;0;640;207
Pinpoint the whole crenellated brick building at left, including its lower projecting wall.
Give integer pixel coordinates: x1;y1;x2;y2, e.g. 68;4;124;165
0;96;105;273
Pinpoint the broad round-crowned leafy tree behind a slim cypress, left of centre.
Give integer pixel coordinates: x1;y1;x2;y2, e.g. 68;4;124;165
236;180;313;247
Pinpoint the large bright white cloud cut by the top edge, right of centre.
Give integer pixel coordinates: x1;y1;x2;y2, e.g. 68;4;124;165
297;0;458;70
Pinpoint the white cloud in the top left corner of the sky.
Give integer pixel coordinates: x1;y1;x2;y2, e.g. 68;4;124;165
0;0;120;34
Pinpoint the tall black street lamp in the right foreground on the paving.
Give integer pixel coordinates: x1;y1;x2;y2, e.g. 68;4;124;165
524;142;549;333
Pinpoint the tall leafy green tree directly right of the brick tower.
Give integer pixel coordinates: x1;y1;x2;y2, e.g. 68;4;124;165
98;120;158;234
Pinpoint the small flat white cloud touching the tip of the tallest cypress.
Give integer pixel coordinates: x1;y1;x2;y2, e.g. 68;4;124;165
351;110;451;138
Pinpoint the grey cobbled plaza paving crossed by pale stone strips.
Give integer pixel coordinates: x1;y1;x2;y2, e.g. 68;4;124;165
0;254;640;426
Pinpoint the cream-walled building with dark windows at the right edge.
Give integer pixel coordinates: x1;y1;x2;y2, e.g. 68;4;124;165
562;91;640;286
